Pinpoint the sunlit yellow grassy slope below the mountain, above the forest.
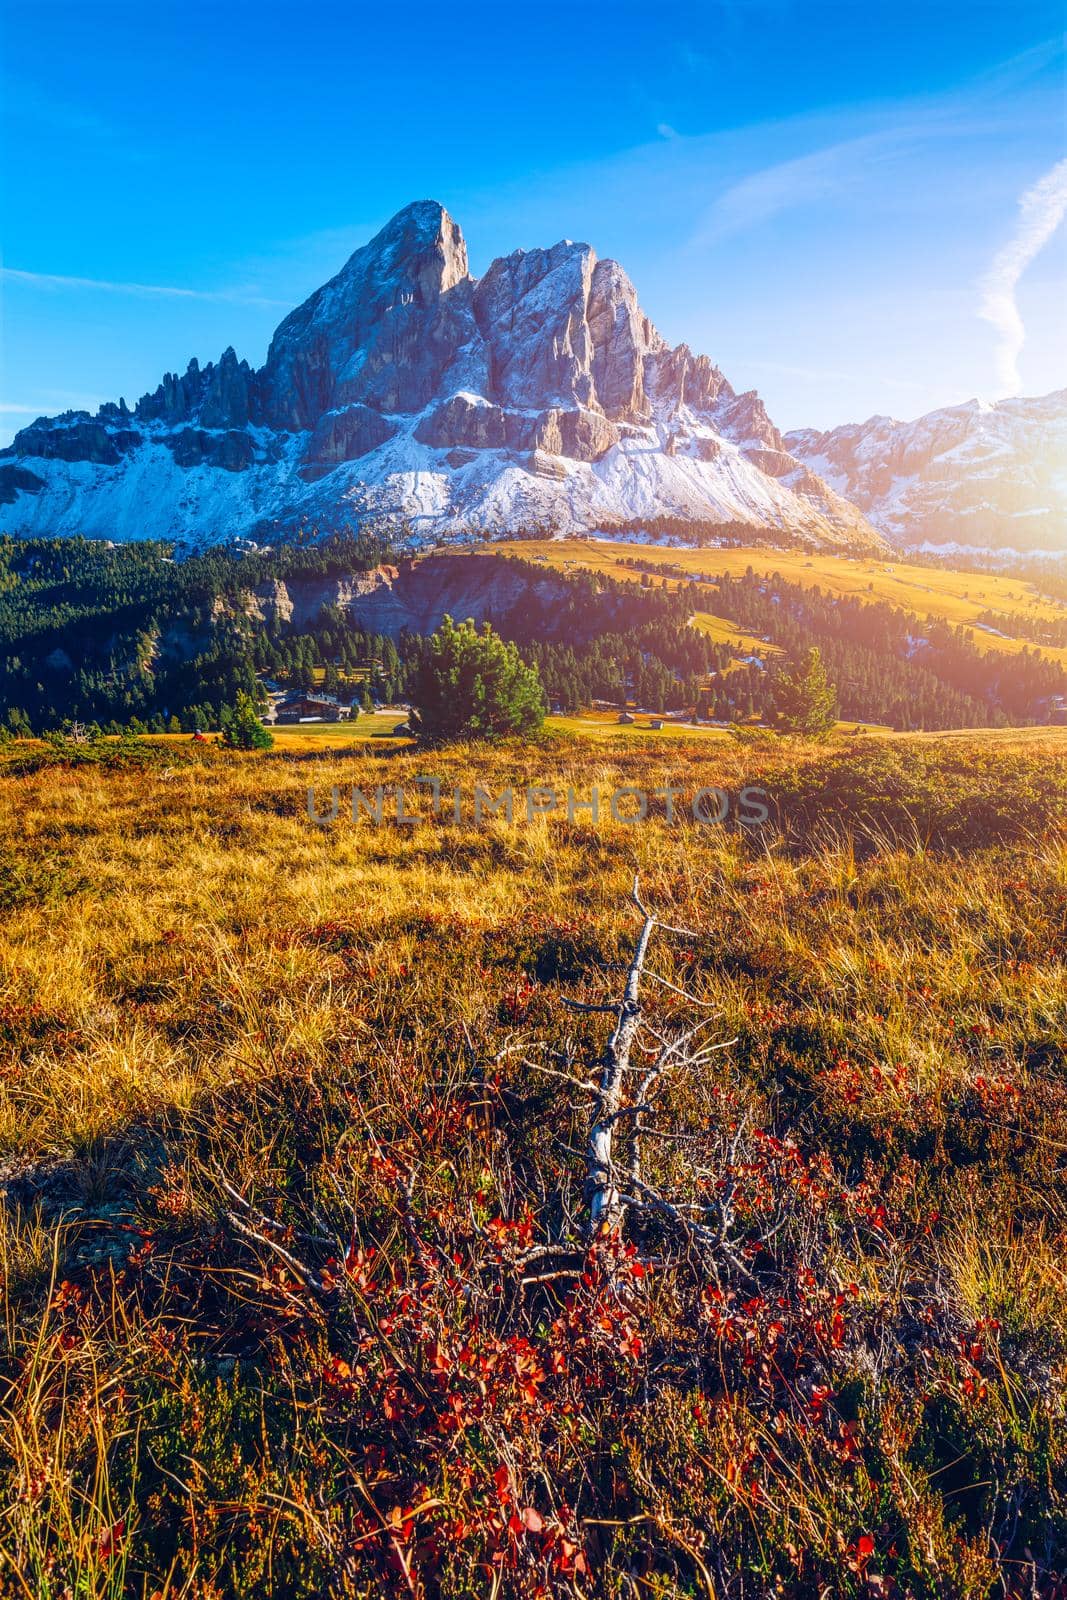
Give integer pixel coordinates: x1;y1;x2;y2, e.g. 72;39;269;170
486;539;1067;667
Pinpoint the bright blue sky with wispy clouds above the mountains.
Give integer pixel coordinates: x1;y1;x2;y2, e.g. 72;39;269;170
0;0;1067;442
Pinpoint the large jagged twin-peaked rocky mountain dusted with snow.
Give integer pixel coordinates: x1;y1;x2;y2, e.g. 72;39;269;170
0;200;880;547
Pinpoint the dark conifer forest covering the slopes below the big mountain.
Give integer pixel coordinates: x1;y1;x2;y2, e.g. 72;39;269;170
0;531;1067;733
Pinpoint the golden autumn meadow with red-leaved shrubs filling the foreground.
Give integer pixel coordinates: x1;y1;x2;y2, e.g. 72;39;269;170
0;731;1067;1600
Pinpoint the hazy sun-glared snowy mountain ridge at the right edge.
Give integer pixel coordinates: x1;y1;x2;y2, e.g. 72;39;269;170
785;389;1067;558
